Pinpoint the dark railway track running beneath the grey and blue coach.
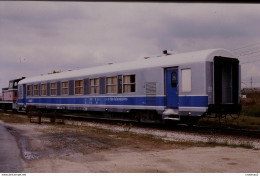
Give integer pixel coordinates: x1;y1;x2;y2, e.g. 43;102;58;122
3;112;260;139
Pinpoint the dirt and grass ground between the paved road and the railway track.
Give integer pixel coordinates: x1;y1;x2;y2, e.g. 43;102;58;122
0;114;260;173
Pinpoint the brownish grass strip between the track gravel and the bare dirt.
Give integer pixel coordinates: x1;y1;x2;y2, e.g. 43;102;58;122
34;121;254;153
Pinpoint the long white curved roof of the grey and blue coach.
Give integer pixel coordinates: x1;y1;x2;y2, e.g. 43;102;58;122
19;49;234;84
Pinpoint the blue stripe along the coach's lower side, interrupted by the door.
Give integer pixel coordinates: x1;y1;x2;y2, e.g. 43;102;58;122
18;96;208;107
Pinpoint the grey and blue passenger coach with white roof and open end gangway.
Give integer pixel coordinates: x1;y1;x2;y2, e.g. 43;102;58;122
18;49;241;120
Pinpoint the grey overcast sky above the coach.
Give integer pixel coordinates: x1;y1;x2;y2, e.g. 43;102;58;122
0;1;260;91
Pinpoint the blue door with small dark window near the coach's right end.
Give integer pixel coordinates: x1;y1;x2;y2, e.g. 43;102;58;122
166;68;179;108
